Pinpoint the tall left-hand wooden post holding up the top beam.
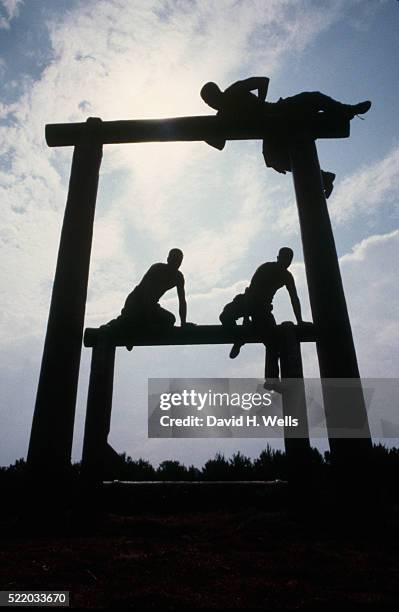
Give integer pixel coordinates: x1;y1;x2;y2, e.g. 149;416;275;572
28;119;102;476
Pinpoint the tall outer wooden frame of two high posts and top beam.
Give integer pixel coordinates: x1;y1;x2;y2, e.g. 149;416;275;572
28;114;371;475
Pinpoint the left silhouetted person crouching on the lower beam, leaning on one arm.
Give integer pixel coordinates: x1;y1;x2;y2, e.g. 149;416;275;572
106;249;192;351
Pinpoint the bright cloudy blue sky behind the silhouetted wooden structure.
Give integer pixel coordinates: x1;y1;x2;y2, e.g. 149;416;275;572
0;0;399;465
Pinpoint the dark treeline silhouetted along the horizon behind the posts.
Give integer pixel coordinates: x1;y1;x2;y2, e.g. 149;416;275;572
0;444;399;489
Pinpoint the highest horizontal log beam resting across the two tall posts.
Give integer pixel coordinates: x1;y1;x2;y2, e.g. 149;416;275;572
46;113;350;147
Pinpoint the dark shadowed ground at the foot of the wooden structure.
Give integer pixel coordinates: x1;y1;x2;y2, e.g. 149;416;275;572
0;483;399;610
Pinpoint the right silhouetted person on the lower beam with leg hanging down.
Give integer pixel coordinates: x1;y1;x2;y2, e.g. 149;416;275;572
219;247;302;390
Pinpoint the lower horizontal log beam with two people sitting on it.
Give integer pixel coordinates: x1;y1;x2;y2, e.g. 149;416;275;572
83;322;316;347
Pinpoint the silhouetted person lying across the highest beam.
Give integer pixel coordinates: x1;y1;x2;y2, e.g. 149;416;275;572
201;77;371;198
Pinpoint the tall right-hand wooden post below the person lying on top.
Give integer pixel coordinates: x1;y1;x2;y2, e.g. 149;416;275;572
290;137;371;461
